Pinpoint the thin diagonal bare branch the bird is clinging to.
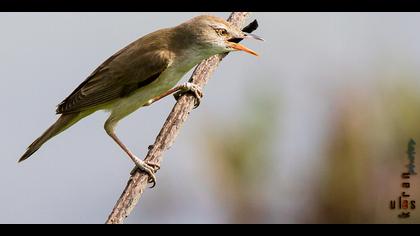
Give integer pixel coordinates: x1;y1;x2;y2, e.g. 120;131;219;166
106;12;254;224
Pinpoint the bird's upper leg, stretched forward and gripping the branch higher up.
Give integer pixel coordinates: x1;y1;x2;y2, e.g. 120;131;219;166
144;82;203;108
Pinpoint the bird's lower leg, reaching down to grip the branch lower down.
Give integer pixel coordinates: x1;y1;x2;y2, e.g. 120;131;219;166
105;123;160;188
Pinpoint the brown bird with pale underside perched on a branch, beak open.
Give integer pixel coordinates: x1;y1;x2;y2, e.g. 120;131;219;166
18;15;263;183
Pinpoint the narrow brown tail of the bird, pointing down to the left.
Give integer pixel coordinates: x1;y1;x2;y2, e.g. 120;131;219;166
18;113;83;162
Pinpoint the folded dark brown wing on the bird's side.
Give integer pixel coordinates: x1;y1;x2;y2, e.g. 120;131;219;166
56;35;172;114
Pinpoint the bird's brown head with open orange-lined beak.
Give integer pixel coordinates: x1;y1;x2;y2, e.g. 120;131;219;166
174;15;263;56
